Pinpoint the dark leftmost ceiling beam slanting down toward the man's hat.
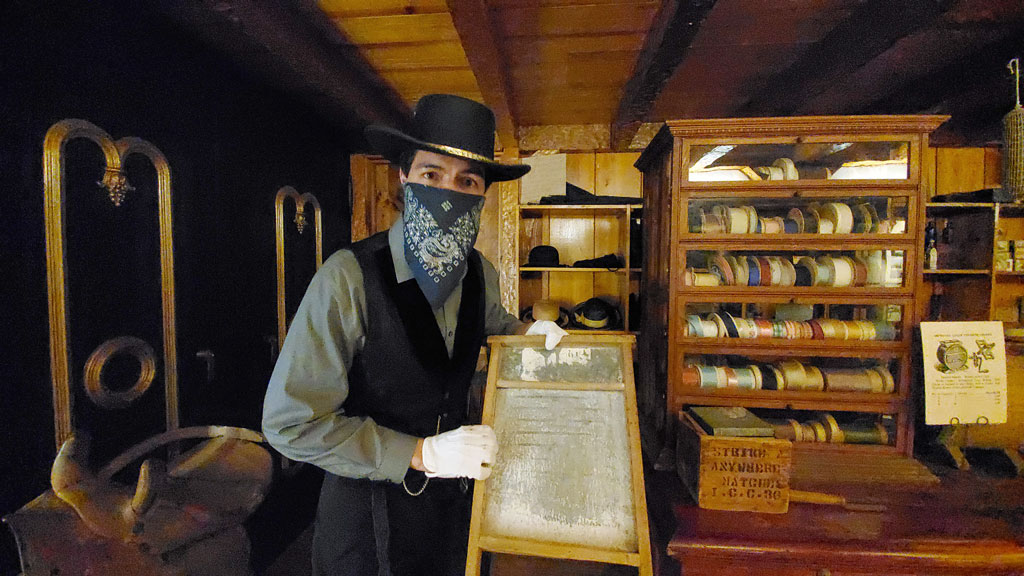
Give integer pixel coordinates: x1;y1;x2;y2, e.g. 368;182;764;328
160;0;412;140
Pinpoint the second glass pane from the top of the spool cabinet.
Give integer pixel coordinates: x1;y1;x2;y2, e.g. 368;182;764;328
686;196;909;237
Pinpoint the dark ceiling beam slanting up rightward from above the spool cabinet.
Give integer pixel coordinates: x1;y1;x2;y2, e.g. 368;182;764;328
731;0;949;116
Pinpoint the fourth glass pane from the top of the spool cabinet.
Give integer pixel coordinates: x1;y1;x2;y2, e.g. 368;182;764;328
679;301;903;342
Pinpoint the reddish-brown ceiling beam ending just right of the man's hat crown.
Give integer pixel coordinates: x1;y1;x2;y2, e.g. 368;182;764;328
447;0;518;150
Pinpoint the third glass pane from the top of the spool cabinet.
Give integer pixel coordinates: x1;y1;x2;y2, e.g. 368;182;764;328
682;249;905;290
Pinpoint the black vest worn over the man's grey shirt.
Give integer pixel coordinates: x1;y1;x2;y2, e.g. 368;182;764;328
345;232;484;437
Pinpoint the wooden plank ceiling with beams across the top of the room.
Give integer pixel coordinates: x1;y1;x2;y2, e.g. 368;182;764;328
184;0;1024;151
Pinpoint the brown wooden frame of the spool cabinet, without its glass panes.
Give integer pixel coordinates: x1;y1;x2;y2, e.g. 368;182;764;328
636;116;948;455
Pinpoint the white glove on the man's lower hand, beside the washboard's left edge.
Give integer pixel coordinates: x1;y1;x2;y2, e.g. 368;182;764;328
423;424;498;480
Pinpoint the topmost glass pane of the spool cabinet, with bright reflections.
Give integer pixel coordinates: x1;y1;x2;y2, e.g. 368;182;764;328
688;141;910;182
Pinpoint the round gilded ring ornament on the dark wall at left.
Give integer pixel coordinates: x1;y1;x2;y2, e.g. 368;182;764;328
85;336;157;410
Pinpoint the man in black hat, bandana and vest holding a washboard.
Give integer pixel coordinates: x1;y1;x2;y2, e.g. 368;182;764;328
263;94;565;576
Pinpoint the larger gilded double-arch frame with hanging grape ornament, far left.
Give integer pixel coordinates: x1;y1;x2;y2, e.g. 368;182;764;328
43;119;178;449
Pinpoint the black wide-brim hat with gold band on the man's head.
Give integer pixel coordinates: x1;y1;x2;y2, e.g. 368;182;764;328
365;94;529;182
